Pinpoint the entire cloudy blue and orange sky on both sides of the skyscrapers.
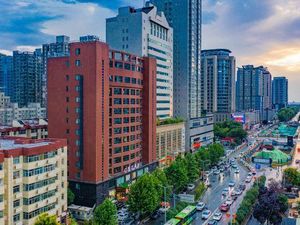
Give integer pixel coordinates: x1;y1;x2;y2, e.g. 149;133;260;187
0;0;300;102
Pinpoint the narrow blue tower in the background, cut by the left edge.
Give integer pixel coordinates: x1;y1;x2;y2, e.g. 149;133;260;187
0;53;13;95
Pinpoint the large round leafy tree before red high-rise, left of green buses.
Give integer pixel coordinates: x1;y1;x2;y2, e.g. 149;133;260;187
128;173;162;215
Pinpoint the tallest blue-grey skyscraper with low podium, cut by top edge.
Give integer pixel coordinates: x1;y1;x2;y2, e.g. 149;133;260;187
151;0;213;150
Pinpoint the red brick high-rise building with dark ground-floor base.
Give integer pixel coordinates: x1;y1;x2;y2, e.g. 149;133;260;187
48;37;156;206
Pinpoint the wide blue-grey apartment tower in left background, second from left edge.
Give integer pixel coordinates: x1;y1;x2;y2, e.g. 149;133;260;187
9;49;42;107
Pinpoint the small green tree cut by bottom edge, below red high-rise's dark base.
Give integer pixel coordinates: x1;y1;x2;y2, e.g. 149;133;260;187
93;199;118;225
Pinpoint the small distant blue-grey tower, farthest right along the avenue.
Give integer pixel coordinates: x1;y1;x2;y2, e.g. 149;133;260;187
272;77;288;110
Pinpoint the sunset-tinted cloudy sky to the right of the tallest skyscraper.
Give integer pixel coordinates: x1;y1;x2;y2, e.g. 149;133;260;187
202;0;300;101
